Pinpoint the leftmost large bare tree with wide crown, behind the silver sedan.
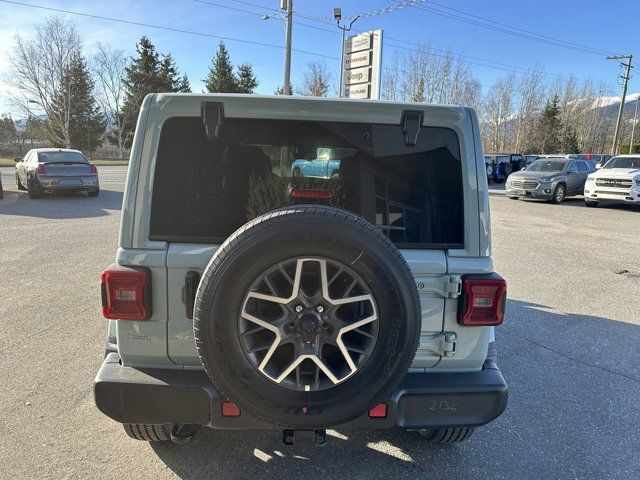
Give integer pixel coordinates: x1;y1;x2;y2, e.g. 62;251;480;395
8;17;81;148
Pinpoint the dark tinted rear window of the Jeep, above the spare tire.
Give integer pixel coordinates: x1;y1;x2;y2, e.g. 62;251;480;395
150;117;464;248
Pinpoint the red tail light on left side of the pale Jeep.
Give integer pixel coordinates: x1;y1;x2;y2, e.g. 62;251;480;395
102;266;151;320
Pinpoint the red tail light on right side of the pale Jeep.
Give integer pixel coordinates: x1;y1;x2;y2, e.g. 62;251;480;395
458;275;507;326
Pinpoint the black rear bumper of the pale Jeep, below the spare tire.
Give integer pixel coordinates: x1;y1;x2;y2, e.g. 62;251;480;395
93;353;508;430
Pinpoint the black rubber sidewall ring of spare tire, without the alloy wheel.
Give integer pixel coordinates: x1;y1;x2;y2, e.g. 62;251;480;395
194;208;420;427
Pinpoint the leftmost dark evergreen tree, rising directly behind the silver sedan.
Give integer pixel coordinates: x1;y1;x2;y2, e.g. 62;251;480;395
48;52;106;155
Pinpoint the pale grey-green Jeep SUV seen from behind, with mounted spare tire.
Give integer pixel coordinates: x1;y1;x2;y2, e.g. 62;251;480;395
94;94;507;444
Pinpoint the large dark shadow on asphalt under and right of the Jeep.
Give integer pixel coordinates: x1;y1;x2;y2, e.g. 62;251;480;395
146;300;640;480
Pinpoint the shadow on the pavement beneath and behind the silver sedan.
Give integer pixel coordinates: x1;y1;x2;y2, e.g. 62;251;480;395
0;190;122;219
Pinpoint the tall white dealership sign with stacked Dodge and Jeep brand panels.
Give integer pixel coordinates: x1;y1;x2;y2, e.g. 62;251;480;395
340;30;382;100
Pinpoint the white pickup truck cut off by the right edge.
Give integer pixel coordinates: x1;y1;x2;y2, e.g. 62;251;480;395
584;155;640;207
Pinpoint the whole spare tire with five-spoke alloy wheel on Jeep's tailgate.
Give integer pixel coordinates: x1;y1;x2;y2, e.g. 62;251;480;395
194;205;421;428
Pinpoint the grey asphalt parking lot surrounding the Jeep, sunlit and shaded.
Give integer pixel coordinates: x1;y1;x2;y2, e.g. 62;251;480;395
0;167;640;479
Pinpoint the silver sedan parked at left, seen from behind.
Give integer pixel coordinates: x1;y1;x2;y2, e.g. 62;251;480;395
15;148;100;198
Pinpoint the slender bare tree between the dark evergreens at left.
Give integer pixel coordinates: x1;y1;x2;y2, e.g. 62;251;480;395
92;42;127;158
